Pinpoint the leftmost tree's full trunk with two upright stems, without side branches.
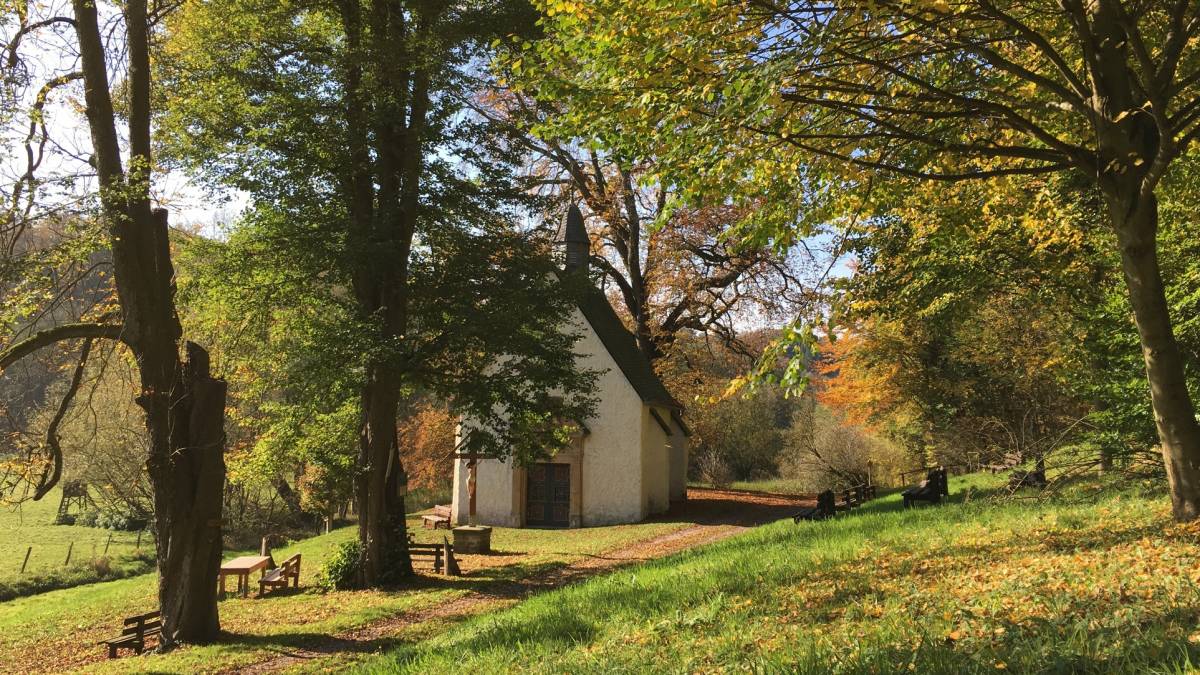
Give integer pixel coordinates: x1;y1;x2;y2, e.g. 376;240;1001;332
72;0;226;650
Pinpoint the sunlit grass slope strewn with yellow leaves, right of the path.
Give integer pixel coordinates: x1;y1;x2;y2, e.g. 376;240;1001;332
362;476;1200;674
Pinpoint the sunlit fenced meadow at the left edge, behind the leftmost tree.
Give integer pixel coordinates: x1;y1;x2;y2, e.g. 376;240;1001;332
0;489;154;583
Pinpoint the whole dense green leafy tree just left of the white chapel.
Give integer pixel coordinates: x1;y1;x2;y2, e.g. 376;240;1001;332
164;0;592;585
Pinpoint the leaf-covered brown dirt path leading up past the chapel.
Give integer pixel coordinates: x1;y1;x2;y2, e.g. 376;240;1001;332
226;490;811;674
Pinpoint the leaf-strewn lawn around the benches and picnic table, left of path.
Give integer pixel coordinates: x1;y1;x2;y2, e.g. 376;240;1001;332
0;506;688;673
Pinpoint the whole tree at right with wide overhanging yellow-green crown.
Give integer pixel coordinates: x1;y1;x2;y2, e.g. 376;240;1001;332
528;0;1200;520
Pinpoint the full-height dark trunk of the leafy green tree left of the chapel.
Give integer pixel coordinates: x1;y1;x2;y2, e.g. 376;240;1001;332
341;0;444;586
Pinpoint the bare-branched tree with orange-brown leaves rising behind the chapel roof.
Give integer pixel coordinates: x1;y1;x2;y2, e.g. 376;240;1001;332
478;93;812;363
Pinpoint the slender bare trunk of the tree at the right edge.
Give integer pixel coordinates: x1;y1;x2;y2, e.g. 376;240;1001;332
1109;192;1200;521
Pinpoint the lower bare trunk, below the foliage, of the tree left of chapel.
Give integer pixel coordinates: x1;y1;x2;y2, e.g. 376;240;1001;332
355;366;413;587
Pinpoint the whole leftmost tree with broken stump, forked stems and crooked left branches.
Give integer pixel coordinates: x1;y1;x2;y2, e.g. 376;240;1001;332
0;0;226;649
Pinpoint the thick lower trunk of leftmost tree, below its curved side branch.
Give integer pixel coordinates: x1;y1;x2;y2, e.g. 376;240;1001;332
145;342;226;649
